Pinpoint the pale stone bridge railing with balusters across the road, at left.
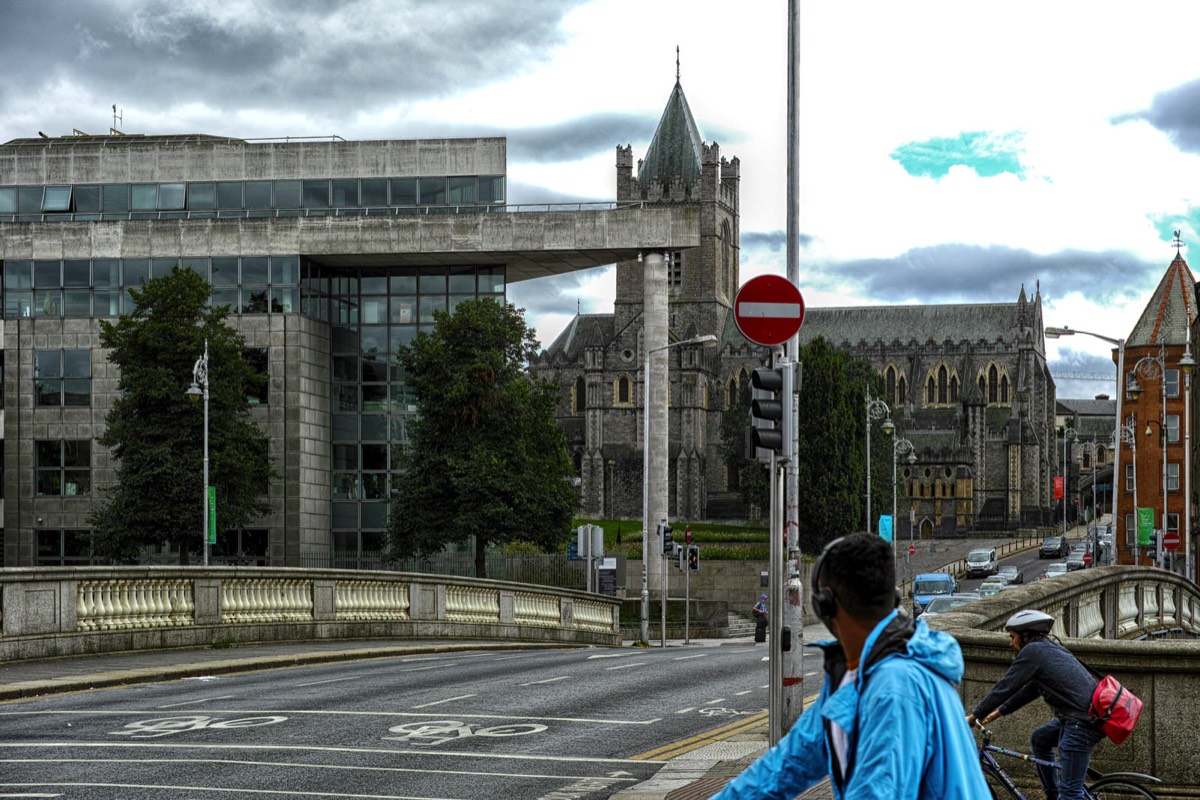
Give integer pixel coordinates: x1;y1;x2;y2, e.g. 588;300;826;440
0;567;620;661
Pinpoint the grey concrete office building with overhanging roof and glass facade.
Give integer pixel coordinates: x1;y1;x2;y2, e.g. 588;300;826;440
0;131;700;566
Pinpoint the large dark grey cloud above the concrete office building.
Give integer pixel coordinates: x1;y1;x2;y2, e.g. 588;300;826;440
0;0;574;136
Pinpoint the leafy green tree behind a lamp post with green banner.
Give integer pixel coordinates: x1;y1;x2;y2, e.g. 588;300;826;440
89;267;276;565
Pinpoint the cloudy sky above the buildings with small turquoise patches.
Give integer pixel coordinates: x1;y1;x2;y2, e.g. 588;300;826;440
0;0;1200;397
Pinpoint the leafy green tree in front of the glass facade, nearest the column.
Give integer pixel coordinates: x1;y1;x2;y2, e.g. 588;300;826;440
388;300;576;577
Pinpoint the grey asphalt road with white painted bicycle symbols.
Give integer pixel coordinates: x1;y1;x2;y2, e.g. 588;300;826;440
0;642;820;800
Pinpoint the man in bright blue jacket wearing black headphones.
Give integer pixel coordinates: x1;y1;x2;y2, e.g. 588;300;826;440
714;534;991;800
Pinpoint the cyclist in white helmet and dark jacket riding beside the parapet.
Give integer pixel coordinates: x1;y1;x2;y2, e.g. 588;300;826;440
967;609;1104;800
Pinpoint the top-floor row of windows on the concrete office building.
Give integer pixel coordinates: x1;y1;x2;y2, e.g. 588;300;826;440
0;175;505;222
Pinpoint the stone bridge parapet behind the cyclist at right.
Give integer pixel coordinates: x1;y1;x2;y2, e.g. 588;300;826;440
929;566;1200;798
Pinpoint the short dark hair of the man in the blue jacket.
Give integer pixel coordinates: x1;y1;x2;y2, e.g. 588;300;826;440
811;534;896;622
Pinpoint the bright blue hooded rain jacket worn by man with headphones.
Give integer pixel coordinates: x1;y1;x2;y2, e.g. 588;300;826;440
714;612;991;800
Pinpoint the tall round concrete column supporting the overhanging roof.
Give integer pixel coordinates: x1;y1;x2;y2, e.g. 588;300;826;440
642;252;670;590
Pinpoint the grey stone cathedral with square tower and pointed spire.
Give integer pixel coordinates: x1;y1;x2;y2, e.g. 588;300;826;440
533;78;1057;537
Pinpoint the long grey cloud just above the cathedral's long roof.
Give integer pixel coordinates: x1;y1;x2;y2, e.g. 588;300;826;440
815;243;1163;303
